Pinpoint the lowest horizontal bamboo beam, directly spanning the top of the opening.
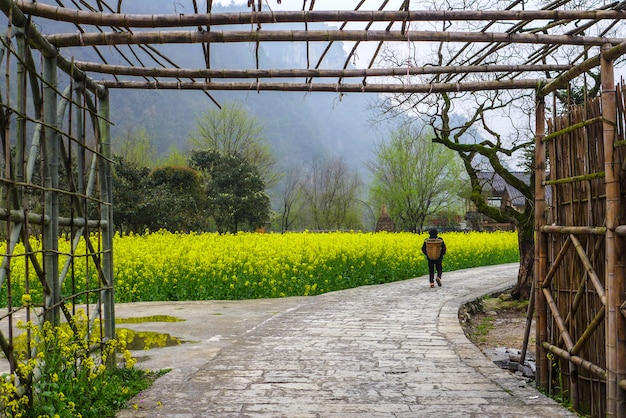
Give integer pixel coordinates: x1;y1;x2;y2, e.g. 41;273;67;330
95;80;542;93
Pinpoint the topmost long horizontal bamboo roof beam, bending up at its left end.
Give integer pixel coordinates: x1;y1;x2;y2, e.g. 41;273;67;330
15;0;624;28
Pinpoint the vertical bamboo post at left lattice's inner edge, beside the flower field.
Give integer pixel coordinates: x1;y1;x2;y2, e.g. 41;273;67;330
98;93;115;339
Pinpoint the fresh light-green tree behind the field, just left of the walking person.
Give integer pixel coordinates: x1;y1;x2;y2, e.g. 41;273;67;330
367;125;463;232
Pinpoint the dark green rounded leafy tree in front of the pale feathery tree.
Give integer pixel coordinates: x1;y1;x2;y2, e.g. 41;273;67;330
190;150;270;233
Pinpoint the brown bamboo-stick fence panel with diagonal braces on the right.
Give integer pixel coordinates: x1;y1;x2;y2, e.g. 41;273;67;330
536;81;626;416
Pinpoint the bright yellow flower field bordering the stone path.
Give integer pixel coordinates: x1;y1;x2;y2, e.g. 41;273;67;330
0;231;519;306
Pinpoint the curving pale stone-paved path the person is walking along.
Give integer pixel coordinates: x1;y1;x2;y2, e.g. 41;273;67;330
116;264;576;418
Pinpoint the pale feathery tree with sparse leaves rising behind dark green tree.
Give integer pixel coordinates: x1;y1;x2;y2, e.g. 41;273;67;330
189;102;278;187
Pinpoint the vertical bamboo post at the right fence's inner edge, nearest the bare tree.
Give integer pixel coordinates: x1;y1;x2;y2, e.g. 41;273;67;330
534;94;549;388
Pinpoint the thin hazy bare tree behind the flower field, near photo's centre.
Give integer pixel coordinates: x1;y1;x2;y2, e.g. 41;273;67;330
302;156;361;230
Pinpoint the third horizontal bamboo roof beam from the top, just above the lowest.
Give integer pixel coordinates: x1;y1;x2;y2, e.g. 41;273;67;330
74;61;571;79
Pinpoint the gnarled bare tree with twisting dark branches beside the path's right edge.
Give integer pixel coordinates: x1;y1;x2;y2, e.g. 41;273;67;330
372;1;534;298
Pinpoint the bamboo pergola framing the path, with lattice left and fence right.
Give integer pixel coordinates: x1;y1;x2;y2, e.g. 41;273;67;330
0;0;626;417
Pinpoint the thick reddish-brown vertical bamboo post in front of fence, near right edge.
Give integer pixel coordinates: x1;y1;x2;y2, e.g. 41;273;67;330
600;40;626;417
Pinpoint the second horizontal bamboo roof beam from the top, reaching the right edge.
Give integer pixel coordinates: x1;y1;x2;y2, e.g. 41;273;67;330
46;29;624;48
